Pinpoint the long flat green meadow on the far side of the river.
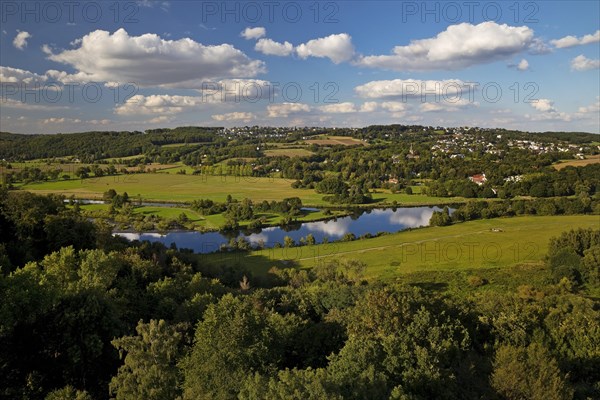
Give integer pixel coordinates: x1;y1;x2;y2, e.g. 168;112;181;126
21;173;462;206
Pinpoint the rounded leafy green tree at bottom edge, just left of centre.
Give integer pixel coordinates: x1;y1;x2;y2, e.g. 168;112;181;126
178;295;300;399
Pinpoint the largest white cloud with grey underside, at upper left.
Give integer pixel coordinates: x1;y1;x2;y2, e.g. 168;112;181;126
47;28;265;88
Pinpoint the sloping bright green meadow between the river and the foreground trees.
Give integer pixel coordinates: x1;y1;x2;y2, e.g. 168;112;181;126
199;215;600;279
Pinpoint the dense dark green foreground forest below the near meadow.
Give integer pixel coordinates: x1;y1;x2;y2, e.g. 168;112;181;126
0;191;600;400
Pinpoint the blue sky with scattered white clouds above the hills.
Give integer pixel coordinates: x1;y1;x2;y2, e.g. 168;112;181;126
0;0;600;133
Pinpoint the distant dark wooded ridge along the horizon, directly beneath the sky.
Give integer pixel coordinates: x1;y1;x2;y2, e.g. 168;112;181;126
0;124;600;162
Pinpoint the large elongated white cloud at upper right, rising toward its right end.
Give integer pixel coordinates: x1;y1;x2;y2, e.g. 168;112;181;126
357;21;534;71
